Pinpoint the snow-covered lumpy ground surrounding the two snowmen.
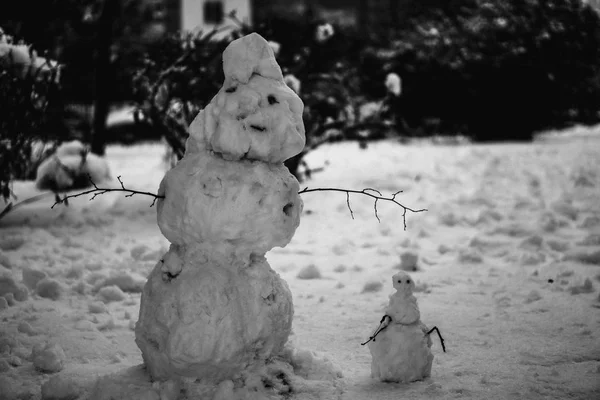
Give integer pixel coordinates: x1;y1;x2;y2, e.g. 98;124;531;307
0;130;600;400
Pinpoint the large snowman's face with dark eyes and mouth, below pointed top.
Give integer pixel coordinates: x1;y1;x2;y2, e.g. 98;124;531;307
210;74;305;162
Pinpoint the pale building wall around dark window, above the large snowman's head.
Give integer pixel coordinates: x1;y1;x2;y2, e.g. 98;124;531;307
181;0;252;32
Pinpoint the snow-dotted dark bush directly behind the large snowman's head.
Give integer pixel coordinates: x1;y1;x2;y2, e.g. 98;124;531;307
134;14;389;179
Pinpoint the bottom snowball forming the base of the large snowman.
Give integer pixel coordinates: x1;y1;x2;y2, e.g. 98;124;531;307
135;249;293;382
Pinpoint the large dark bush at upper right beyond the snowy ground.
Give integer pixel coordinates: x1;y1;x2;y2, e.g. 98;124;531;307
372;0;600;141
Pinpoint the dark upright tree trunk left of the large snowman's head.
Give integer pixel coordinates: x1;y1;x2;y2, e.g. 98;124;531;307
91;0;120;155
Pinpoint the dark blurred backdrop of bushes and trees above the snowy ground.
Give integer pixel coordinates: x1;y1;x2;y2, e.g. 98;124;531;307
0;0;600;199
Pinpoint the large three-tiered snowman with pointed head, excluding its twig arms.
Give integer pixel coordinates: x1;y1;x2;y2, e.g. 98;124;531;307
135;34;305;382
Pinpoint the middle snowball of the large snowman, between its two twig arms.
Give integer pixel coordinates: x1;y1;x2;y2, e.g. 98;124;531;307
157;154;303;256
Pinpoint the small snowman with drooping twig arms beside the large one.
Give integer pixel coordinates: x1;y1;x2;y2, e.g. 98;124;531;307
363;271;443;383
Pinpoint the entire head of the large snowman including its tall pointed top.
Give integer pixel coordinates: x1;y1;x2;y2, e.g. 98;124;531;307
187;33;305;163
